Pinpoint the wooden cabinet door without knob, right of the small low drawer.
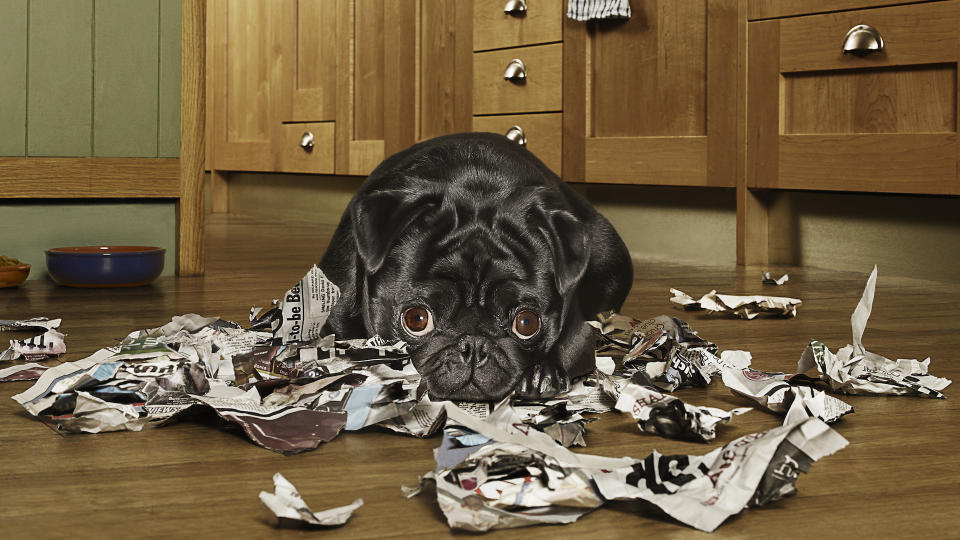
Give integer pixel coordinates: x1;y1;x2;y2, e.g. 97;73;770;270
336;0;417;174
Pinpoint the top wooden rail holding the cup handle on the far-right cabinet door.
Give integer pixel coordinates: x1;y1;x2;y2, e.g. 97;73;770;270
779;1;960;73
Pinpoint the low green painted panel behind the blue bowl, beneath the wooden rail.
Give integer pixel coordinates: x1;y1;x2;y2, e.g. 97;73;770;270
0;201;177;280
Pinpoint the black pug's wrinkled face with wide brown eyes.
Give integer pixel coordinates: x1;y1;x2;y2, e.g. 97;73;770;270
367;219;565;401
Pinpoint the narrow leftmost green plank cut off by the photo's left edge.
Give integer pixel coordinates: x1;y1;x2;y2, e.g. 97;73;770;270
0;0;27;156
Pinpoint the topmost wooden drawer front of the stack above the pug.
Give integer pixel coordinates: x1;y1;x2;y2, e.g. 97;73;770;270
473;0;564;51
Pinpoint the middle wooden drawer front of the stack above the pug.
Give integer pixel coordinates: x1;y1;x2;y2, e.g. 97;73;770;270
473;43;563;114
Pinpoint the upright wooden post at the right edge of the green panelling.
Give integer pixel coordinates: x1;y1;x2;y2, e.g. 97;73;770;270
177;0;207;276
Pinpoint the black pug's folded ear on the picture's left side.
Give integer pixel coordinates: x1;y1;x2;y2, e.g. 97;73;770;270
350;190;426;274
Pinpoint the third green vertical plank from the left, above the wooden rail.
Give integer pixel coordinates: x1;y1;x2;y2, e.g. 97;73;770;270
93;0;160;157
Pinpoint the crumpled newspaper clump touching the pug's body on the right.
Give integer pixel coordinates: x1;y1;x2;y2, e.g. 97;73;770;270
589;311;722;392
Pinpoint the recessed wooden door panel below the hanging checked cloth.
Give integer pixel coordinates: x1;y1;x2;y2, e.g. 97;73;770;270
590;0;704;137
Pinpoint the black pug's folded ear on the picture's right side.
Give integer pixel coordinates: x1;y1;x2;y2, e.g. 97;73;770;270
543;210;590;295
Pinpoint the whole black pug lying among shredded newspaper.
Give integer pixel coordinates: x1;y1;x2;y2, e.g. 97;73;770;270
320;133;633;401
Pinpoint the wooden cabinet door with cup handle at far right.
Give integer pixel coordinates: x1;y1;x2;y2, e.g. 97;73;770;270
747;2;960;194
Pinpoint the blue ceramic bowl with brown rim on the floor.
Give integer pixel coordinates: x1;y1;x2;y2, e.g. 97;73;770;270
46;246;166;287
